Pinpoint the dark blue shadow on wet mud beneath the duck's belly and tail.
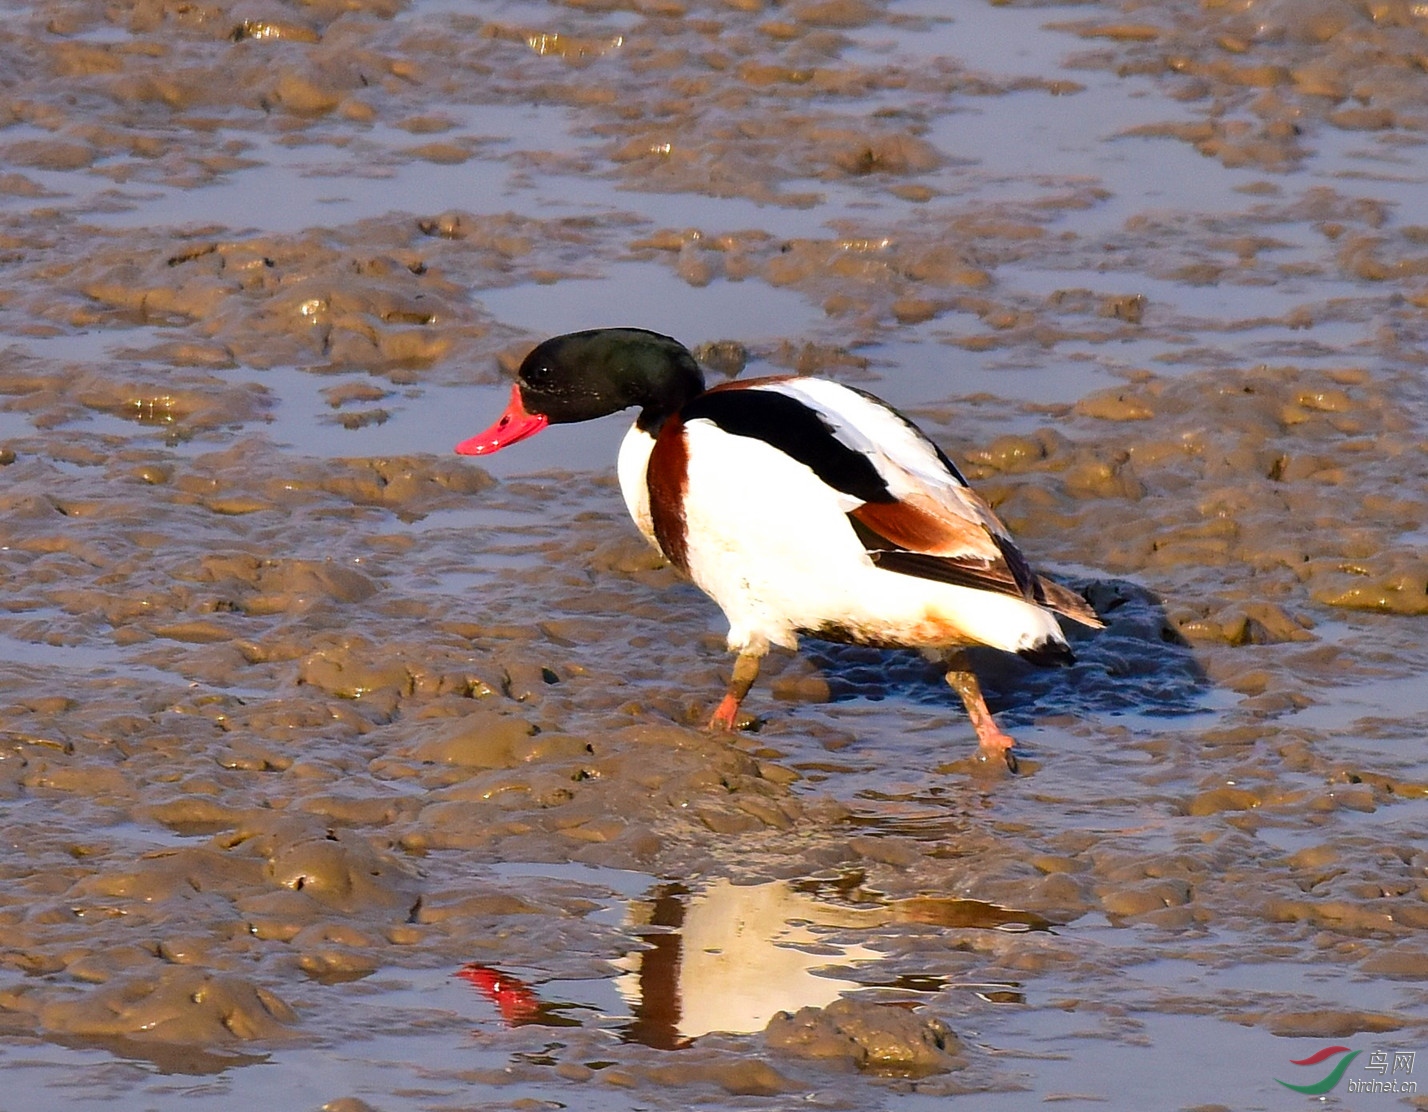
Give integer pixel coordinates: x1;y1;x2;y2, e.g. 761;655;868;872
804;580;1210;724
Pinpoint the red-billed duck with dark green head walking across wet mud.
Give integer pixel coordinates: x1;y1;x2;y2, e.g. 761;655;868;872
456;327;1102;772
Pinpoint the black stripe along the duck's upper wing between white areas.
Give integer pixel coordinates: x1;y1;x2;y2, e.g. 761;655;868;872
680;388;895;502
